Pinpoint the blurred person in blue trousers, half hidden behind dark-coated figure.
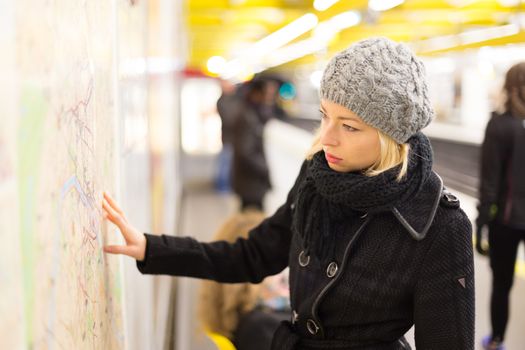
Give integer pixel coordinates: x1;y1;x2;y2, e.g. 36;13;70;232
215;79;242;192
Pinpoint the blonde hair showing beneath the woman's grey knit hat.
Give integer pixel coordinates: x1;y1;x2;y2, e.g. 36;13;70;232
306;128;410;181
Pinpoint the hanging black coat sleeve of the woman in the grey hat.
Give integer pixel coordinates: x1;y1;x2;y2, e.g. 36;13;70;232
414;209;475;350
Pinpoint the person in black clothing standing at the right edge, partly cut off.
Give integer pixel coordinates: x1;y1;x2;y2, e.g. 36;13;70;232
476;62;525;350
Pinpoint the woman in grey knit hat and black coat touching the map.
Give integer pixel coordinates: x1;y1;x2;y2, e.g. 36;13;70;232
103;38;474;350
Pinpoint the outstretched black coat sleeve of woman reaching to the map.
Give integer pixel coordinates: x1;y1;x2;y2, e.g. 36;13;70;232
137;165;305;283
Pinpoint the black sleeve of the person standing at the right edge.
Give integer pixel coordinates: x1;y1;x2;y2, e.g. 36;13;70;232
476;115;508;227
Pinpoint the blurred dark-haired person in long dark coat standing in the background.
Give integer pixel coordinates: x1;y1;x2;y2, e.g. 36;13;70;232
232;80;271;210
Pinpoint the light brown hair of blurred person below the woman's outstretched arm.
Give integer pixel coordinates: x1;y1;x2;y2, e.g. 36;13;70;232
198;209;264;339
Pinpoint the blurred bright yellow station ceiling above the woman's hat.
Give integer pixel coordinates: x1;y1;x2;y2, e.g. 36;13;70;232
185;0;525;72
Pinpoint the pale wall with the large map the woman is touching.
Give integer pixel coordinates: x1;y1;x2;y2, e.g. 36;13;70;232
0;0;181;349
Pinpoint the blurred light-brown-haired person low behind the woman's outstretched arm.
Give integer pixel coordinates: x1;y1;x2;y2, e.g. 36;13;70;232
199;210;290;350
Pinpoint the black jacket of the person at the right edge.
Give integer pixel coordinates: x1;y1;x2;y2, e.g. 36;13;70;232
477;113;525;229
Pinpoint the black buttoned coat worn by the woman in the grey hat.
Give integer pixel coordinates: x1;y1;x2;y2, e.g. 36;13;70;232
137;163;474;350
